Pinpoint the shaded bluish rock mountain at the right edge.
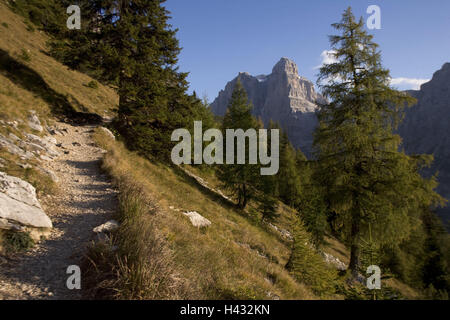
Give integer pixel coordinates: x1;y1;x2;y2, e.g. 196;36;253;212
399;63;450;221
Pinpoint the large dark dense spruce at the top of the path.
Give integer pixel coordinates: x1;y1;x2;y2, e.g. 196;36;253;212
53;0;212;157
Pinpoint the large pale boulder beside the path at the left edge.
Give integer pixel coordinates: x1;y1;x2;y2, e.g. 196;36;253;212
0;172;52;230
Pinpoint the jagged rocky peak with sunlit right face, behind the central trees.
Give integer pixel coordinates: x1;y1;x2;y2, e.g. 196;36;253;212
211;58;324;154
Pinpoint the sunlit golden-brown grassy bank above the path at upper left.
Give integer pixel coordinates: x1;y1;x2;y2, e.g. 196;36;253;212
0;1;118;120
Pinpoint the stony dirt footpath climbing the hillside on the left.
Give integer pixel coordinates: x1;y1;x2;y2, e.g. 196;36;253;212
0;123;117;299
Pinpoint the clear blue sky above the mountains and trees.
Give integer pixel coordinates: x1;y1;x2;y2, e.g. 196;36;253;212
165;0;450;101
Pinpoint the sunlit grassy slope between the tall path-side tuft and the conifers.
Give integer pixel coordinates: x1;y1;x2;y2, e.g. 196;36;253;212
97;129;315;299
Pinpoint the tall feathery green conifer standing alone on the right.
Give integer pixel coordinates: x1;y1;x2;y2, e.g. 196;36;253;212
314;8;441;275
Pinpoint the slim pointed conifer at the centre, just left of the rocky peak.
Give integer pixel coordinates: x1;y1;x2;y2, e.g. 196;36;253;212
218;80;260;209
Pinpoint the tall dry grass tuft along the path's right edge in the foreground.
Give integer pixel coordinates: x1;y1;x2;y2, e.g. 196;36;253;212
85;174;186;300
